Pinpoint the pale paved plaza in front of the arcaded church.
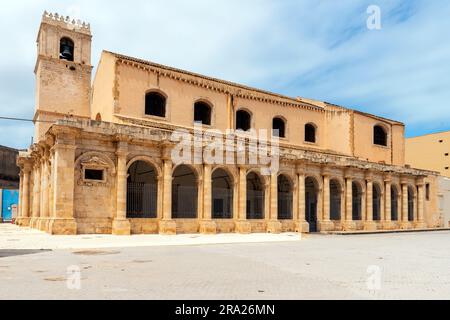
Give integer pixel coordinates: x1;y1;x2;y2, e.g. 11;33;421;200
0;225;450;299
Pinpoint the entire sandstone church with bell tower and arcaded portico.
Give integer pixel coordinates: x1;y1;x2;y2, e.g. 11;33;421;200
17;13;442;235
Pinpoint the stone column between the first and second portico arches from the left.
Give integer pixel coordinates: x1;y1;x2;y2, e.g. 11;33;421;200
159;145;177;235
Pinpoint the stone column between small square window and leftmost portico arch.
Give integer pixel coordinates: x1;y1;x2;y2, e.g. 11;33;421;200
112;139;131;236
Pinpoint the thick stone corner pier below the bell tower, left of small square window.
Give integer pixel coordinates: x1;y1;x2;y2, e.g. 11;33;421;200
48;128;77;235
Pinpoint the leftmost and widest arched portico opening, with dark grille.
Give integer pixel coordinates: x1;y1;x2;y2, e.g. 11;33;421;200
127;161;158;219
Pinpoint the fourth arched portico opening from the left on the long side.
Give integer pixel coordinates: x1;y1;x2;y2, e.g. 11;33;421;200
247;172;264;220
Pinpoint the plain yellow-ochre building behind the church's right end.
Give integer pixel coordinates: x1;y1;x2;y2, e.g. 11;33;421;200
406;131;450;178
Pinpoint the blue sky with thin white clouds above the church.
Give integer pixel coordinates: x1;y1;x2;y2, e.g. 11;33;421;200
0;0;450;148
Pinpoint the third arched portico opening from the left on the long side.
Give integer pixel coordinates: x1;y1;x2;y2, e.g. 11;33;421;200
212;169;233;219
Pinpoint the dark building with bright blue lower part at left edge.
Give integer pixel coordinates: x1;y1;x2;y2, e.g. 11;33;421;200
0;146;20;222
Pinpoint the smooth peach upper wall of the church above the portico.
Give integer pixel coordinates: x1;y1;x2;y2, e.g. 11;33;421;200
91;52;404;165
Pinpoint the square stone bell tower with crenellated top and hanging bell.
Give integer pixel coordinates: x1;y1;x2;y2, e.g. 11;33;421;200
34;12;92;143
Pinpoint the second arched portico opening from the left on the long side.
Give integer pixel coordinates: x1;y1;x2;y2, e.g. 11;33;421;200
172;165;198;219
